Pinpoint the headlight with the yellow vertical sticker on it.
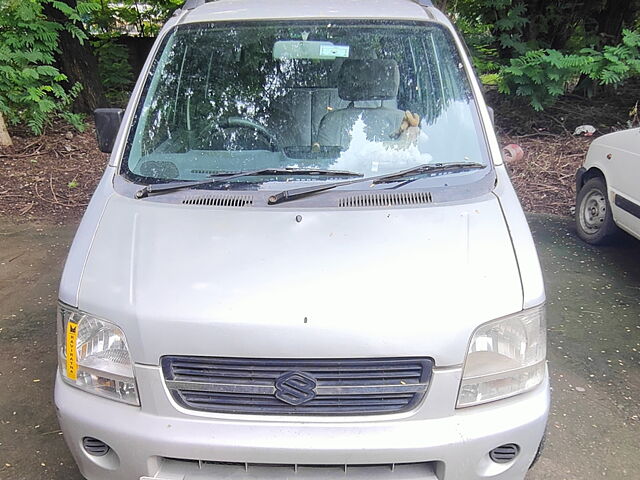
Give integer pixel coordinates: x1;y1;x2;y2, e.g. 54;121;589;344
58;304;140;405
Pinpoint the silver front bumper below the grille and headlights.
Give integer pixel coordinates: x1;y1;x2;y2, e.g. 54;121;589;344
55;365;549;480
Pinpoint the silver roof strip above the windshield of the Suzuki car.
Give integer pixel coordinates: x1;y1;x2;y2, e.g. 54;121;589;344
178;0;441;24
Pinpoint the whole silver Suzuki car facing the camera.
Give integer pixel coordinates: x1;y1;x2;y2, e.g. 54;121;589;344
55;0;549;480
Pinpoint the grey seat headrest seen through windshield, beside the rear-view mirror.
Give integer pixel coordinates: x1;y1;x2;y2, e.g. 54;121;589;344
338;59;400;102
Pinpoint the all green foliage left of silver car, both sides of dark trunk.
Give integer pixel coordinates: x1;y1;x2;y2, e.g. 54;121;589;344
0;0;184;135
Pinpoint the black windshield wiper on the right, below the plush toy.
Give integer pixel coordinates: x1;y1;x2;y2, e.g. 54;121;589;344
268;162;486;205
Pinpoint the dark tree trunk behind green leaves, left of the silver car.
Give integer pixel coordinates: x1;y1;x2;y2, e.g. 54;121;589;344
44;0;108;113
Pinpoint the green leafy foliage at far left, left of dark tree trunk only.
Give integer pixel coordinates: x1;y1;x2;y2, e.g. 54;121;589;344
0;0;92;134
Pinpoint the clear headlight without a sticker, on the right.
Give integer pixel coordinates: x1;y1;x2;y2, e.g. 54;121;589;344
457;305;547;408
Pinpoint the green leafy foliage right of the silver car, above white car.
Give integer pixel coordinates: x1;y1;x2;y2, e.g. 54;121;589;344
450;0;640;110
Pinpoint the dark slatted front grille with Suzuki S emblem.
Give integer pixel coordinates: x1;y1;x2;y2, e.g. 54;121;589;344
162;356;433;415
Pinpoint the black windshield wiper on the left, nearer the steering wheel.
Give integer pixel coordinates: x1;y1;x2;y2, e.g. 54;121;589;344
135;167;362;198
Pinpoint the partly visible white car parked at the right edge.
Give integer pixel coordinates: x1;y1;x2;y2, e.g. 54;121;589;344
576;128;640;245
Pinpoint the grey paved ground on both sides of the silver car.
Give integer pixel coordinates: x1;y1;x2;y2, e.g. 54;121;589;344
0;215;640;480
